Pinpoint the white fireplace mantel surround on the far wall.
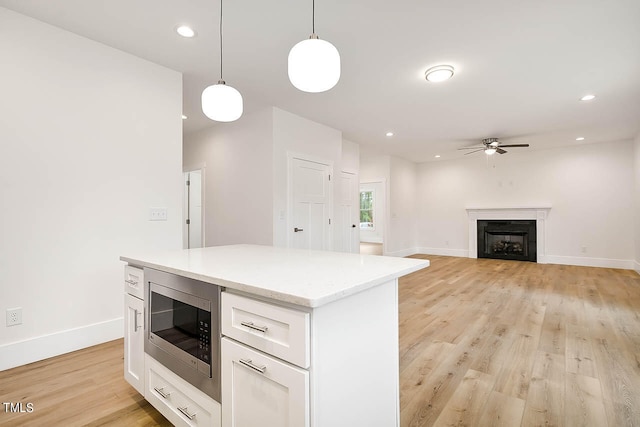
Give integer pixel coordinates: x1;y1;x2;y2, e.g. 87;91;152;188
466;205;551;264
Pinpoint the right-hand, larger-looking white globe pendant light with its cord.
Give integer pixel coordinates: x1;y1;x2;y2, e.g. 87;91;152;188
289;0;340;93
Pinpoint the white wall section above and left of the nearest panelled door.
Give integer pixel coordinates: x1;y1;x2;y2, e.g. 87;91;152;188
273;107;342;246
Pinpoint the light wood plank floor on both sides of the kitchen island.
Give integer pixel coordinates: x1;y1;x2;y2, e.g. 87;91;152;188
0;255;640;427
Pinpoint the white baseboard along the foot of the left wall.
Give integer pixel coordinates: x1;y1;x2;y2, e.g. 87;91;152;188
0;317;124;371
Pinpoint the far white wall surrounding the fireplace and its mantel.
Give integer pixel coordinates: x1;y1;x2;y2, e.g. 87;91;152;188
417;141;634;268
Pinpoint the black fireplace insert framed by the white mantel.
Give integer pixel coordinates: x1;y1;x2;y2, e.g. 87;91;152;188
477;220;537;262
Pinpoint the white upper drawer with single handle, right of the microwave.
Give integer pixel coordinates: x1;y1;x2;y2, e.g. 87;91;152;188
222;292;309;369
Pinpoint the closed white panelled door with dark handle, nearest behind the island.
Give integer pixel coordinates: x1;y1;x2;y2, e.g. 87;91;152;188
287;158;331;250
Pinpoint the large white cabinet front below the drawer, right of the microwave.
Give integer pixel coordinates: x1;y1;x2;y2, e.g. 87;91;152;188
222;338;309;427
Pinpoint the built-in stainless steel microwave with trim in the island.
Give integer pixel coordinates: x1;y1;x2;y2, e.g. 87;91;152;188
144;268;221;402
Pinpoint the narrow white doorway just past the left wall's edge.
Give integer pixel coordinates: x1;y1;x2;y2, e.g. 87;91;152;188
182;168;204;249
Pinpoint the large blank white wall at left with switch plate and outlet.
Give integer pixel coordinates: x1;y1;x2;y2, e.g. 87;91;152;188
0;8;182;370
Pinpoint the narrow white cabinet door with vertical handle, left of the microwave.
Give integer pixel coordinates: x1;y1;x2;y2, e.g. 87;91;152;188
124;294;144;395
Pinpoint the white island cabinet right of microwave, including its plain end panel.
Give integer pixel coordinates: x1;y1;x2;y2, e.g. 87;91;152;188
221;280;399;427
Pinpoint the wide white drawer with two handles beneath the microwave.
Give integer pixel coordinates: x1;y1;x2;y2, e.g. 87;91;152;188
145;355;222;427
